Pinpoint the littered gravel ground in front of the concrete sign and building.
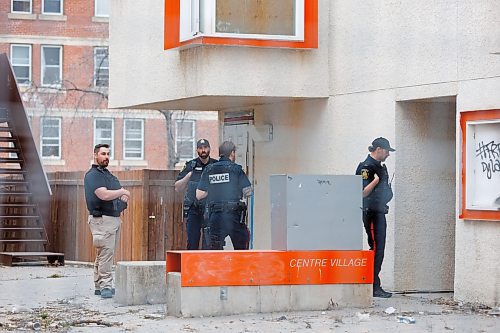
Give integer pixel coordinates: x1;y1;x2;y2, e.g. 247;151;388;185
0;264;500;333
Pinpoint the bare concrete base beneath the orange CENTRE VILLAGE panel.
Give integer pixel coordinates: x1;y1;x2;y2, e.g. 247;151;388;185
167;272;372;317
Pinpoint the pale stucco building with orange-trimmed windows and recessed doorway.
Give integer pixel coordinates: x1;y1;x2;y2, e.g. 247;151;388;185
110;0;500;305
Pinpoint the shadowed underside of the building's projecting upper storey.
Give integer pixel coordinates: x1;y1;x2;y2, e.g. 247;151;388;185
119;95;328;111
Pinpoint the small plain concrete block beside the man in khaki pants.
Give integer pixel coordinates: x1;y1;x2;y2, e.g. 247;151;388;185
115;261;167;305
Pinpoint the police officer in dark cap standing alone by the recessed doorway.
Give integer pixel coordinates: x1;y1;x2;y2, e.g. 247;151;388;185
356;137;396;298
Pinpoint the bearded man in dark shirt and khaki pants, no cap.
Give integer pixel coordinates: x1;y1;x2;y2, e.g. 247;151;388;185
84;144;130;298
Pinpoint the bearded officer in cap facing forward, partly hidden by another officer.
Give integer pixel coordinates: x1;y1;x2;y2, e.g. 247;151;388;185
175;139;217;250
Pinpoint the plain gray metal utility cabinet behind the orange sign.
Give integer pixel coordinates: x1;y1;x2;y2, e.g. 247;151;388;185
270;174;364;250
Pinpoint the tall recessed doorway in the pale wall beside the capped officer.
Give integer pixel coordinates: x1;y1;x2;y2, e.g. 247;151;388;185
394;97;456;291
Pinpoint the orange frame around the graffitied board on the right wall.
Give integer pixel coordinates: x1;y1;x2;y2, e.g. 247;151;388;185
459;109;500;221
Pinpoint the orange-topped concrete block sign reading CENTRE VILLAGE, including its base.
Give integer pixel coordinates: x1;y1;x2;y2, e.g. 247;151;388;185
166;250;373;317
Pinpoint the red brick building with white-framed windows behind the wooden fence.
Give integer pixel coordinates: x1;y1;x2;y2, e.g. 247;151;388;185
0;0;218;172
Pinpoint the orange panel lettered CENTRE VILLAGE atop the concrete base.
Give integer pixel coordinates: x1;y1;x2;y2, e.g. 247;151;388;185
166;250;373;287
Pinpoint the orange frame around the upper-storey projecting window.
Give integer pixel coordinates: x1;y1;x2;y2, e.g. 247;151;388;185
163;0;318;50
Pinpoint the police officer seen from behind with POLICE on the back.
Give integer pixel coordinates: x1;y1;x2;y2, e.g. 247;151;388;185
196;141;252;250
